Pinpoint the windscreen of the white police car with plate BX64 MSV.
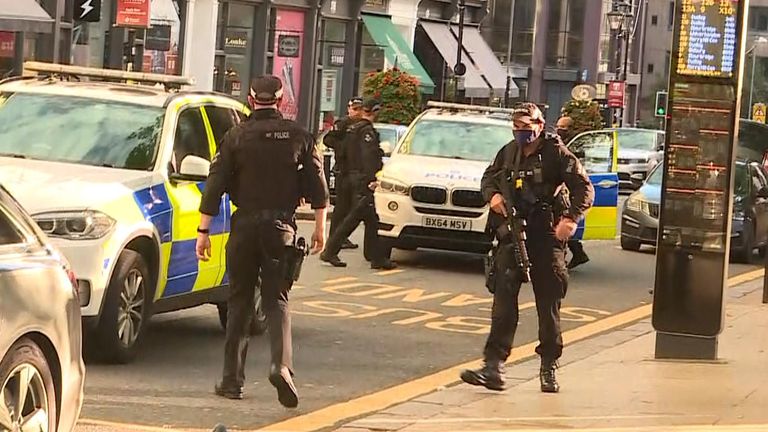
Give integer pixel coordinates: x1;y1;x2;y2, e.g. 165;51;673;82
397;120;513;161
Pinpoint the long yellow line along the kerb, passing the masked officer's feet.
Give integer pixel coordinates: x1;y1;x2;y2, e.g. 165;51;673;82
261;270;763;432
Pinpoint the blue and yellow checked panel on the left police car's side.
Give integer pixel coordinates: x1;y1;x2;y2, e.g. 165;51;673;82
134;183;230;299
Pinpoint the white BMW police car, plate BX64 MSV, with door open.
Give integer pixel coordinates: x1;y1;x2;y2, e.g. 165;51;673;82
375;102;619;254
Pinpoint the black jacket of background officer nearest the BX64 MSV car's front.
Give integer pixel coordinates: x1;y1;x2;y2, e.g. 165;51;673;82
344;119;384;185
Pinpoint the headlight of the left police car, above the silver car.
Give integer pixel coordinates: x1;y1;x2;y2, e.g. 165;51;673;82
33;210;115;240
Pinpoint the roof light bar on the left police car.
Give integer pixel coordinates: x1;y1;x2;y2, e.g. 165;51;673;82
24;62;195;87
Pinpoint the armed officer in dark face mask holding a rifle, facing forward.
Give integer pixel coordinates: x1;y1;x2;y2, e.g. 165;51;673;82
461;103;594;393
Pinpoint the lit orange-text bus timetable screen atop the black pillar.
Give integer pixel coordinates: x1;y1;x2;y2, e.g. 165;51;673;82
677;0;739;78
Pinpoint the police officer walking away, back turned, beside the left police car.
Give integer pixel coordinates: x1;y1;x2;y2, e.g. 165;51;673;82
196;76;328;407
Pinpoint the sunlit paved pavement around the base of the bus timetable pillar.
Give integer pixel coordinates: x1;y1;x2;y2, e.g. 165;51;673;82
336;280;768;432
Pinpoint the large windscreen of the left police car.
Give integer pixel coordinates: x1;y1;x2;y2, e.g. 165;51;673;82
0;93;164;170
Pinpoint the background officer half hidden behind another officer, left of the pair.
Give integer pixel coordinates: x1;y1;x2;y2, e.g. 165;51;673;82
323;96;363;249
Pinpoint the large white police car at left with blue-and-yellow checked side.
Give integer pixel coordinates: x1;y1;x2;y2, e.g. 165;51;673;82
0;63;265;362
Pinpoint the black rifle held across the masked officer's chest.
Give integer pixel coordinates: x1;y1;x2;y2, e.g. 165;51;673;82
496;170;531;283
